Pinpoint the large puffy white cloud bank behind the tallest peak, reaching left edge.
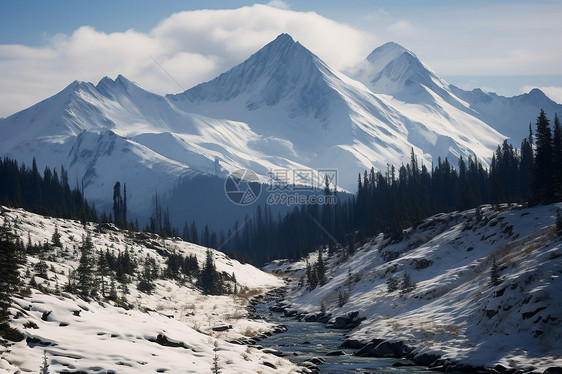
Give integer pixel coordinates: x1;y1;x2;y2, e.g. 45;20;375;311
0;1;376;116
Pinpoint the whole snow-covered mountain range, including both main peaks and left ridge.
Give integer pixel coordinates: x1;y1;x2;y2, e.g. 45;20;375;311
0;34;552;228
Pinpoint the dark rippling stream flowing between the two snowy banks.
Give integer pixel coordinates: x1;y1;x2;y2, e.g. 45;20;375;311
256;303;428;374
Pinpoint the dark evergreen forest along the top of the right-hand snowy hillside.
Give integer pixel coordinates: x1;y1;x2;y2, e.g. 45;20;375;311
217;110;562;264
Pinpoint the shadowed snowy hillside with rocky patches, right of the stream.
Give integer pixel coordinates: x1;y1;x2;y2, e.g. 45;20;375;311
267;204;562;373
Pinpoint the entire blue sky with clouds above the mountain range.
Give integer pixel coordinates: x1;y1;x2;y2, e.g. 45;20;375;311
0;0;562;116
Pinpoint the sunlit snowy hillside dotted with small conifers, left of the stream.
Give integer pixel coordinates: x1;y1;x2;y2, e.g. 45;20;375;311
0;207;296;373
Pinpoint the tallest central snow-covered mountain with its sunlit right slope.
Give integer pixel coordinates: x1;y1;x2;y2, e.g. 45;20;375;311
168;34;503;190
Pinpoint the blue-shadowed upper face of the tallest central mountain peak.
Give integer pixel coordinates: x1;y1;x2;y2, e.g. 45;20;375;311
169;34;332;117
